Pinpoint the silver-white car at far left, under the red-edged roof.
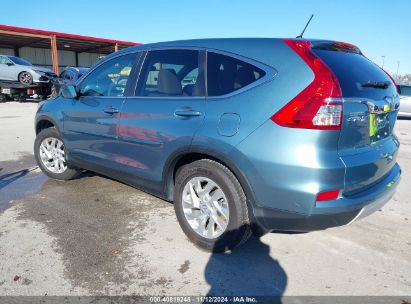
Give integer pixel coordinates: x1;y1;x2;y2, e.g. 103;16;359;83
0;55;56;85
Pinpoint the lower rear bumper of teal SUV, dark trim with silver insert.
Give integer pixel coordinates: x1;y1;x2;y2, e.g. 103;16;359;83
253;164;401;232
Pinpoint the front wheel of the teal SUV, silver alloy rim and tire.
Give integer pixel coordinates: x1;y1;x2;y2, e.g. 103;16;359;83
34;128;80;180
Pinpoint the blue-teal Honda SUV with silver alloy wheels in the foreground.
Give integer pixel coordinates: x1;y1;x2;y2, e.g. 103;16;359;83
34;39;401;252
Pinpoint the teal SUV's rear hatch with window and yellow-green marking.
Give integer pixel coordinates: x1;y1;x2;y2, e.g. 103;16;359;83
312;42;399;196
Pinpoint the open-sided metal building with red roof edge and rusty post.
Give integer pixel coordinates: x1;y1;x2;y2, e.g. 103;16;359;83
0;24;139;74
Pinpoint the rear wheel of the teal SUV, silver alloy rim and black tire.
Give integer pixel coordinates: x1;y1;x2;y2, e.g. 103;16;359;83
174;159;252;252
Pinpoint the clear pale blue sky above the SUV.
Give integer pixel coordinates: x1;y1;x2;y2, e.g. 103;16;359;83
0;0;411;74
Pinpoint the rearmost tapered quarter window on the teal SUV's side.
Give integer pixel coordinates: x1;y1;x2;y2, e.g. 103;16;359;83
207;52;265;96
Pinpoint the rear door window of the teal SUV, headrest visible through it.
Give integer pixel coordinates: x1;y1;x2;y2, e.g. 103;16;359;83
136;50;204;97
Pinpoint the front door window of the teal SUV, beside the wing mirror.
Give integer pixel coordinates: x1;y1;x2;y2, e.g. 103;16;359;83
78;54;137;96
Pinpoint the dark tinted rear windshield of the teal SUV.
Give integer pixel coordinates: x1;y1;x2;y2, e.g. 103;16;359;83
313;49;396;100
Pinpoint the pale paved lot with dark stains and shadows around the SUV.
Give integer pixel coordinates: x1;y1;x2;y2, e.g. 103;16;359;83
0;103;411;295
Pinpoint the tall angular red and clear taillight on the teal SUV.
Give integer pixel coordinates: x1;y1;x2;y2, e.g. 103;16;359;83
271;39;343;130
